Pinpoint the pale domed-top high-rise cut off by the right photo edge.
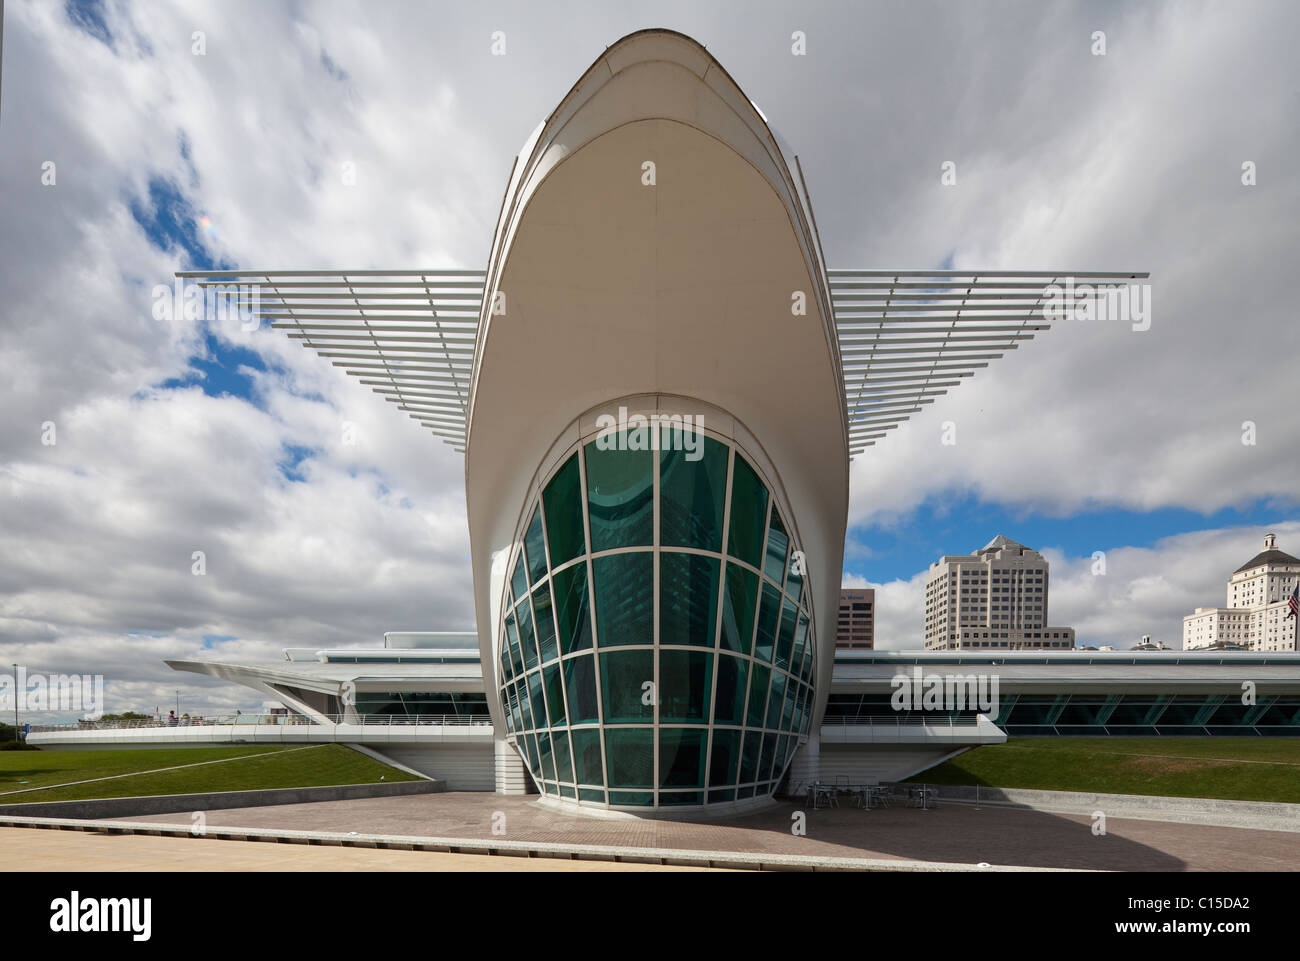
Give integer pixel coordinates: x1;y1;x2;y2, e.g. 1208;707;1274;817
1183;534;1300;652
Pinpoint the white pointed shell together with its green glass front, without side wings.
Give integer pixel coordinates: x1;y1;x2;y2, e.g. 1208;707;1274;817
465;31;849;806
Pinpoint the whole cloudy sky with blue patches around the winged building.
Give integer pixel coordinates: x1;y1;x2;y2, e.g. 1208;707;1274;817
0;0;1300;711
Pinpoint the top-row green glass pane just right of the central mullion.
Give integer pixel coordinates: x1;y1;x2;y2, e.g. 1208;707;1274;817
659;429;727;551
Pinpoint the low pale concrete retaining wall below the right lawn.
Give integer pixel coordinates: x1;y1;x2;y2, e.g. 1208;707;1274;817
898;778;1300;832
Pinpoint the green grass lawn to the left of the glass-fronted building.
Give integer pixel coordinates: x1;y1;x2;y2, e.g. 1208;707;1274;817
0;744;416;805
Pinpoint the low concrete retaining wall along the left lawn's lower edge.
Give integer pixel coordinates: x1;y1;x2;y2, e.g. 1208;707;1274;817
0;780;447;821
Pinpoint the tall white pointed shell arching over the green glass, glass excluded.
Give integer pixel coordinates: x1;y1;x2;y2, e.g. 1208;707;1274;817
465;30;849;759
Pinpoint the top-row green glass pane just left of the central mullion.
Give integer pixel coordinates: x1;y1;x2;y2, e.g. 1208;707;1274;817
586;433;654;551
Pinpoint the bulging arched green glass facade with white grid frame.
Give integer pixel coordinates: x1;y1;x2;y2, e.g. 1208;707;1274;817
498;429;816;808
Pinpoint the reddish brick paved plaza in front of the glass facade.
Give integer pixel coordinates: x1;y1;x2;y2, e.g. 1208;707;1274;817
106;792;1300;871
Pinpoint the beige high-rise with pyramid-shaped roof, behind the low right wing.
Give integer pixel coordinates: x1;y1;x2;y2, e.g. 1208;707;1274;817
926;534;1074;650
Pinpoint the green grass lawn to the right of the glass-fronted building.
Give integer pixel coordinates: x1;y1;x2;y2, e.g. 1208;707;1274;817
910;737;1300;804
